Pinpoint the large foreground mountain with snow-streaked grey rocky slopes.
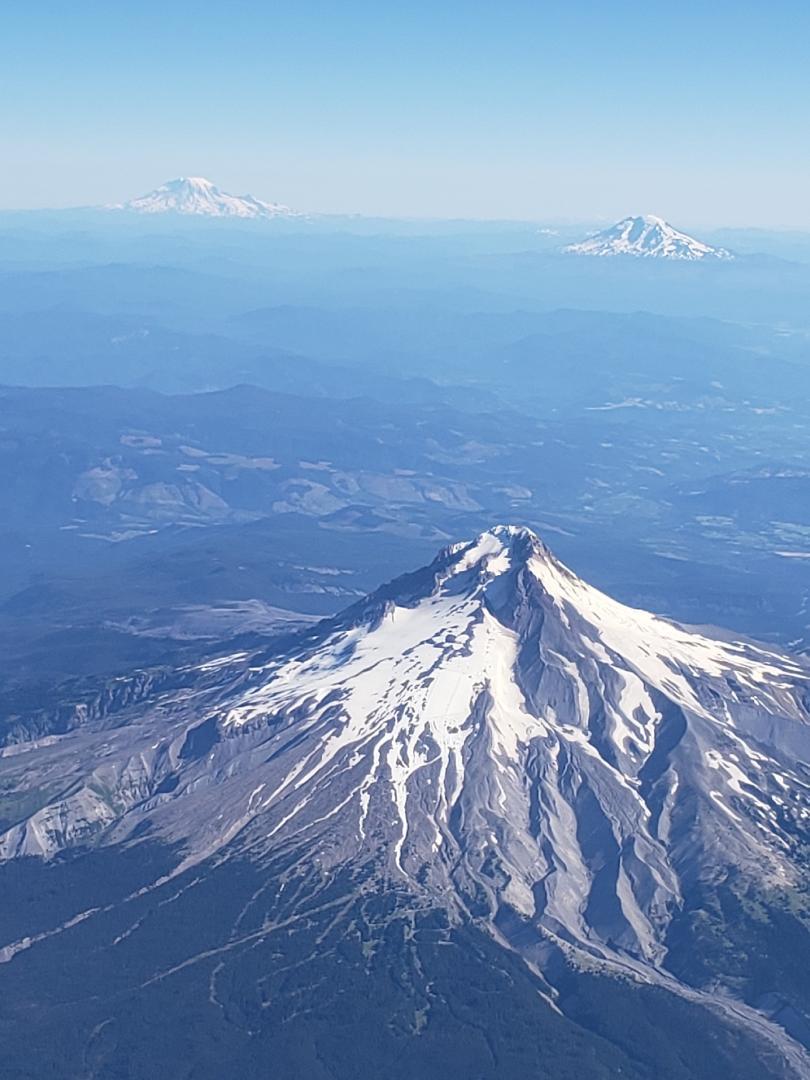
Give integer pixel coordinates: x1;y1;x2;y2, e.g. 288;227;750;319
0;526;810;1076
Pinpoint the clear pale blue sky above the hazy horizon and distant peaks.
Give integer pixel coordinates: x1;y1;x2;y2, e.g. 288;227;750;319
0;0;810;227
